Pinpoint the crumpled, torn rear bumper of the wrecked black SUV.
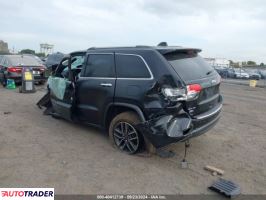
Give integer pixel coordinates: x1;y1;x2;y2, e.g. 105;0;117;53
136;104;222;148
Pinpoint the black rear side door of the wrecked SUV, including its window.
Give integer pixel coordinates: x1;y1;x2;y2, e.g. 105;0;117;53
76;53;116;125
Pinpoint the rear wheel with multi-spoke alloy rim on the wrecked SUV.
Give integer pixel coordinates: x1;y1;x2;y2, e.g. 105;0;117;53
109;112;144;154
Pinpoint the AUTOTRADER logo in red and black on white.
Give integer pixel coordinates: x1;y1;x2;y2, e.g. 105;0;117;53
0;188;54;200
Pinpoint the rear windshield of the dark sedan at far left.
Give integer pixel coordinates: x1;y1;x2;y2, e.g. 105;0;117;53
8;55;41;67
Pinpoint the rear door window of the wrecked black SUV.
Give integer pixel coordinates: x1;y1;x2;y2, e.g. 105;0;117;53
84;54;115;77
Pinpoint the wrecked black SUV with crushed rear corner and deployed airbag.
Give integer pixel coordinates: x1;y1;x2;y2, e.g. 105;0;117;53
38;46;222;154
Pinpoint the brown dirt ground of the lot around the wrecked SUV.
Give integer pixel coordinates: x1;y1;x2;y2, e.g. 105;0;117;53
0;84;266;194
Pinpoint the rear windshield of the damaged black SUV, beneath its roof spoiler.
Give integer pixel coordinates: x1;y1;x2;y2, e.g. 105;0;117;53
164;52;214;81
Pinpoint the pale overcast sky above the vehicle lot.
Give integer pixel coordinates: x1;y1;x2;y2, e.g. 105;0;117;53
0;0;266;63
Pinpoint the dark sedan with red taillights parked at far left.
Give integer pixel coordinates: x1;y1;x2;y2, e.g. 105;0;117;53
0;55;46;86
